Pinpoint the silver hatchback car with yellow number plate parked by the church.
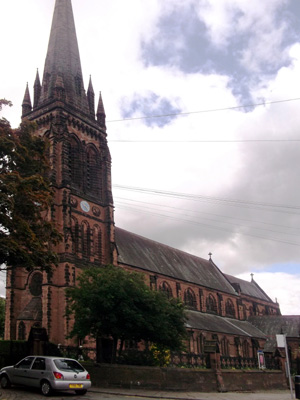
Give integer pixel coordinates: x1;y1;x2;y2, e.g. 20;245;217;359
0;356;91;396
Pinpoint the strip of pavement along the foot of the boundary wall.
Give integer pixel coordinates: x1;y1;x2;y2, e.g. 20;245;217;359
90;388;295;400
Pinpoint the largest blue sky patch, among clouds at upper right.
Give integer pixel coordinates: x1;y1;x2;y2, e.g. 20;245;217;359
141;2;299;106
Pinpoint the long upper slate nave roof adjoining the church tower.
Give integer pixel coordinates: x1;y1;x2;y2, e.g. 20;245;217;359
115;228;237;295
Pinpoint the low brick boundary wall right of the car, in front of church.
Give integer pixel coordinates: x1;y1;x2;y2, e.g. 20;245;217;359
86;364;288;392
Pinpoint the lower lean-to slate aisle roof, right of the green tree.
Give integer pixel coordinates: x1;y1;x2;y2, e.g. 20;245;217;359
186;311;266;339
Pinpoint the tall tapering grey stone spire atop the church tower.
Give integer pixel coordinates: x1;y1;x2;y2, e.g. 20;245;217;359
39;0;90;114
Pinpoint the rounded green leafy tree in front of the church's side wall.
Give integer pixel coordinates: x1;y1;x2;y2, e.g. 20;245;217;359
67;266;186;361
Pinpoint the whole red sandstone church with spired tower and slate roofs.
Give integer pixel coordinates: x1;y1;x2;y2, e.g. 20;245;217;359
5;0;299;370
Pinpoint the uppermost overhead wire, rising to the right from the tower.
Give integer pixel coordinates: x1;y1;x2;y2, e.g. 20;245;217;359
106;97;300;123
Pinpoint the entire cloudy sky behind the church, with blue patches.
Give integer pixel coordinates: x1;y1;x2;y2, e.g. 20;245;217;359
0;0;300;315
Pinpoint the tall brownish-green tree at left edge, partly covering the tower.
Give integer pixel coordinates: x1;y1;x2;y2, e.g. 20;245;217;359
0;100;61;271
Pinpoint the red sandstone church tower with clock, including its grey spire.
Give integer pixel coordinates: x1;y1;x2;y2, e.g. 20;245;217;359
6;0;117;344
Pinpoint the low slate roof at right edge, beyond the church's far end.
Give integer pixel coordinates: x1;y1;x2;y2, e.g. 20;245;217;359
248;315;300;352
